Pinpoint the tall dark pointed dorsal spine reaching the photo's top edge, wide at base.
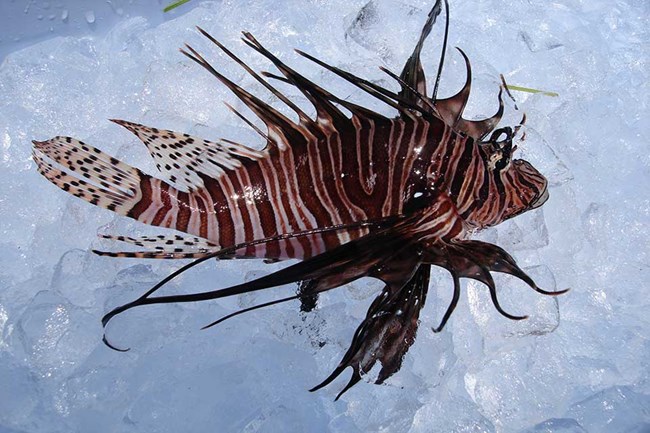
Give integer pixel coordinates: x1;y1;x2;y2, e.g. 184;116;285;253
399;0;442;108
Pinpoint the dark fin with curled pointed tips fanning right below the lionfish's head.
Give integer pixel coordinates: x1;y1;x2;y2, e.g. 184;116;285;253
423;240;568;332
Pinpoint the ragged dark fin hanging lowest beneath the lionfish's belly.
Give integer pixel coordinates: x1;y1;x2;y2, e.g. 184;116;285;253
310;264;431;400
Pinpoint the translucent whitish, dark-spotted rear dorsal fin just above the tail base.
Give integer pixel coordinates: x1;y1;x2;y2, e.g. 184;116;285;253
111;119;265;191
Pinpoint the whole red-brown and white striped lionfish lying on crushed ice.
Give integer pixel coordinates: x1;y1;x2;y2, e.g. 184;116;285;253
33;0;565;399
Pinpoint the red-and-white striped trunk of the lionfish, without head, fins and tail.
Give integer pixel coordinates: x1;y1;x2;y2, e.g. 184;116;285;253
123;117;450;259
